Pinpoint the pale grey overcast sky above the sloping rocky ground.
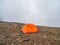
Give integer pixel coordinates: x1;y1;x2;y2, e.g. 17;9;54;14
0;0;60;27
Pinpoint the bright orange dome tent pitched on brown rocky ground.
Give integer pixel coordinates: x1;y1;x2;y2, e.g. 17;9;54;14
22;24;38;33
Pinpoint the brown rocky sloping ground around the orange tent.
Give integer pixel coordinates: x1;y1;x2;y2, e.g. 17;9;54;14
0;21;60;45
